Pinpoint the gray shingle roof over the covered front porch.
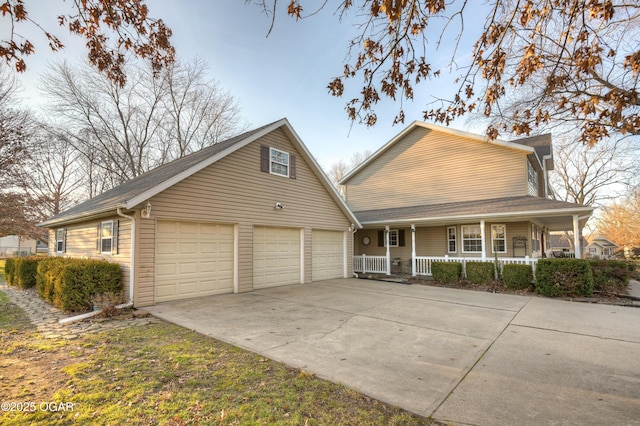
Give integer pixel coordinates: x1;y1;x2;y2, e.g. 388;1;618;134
354;196;593;225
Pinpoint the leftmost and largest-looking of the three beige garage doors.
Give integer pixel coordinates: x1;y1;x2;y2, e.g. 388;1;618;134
155;221;233;302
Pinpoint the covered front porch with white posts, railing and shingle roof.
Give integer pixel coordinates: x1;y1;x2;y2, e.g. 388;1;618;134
353;197;593;277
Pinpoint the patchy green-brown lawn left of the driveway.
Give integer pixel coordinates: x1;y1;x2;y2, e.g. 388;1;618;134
0;292;437;425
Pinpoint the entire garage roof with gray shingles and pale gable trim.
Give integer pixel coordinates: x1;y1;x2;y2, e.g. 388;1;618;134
38;118;359;227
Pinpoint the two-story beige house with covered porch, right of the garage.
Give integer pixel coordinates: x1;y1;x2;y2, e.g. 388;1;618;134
340;122;593;275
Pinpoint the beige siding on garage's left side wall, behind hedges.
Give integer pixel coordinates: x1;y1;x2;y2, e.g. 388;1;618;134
49;216;131;300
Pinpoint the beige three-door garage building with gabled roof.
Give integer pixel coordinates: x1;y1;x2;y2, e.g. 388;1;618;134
39;119;359;306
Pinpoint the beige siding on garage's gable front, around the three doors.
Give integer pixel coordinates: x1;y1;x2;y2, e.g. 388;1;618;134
138;129;351;306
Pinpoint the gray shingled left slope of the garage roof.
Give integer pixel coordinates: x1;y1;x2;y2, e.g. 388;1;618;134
38;122;277;226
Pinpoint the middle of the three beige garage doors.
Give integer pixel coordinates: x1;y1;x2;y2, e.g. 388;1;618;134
253;226;300;288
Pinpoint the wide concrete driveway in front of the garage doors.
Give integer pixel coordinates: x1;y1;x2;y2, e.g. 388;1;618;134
148;279;640;425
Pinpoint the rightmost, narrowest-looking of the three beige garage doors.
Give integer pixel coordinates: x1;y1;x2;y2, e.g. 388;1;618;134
311;229;344;281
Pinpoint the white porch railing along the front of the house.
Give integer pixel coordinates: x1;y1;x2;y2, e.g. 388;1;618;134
353;254;538;276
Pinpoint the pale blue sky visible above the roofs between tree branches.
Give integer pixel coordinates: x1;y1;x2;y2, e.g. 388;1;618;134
13;0;483;167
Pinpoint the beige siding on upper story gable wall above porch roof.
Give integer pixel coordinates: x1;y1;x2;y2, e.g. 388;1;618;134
346;128;528;211
